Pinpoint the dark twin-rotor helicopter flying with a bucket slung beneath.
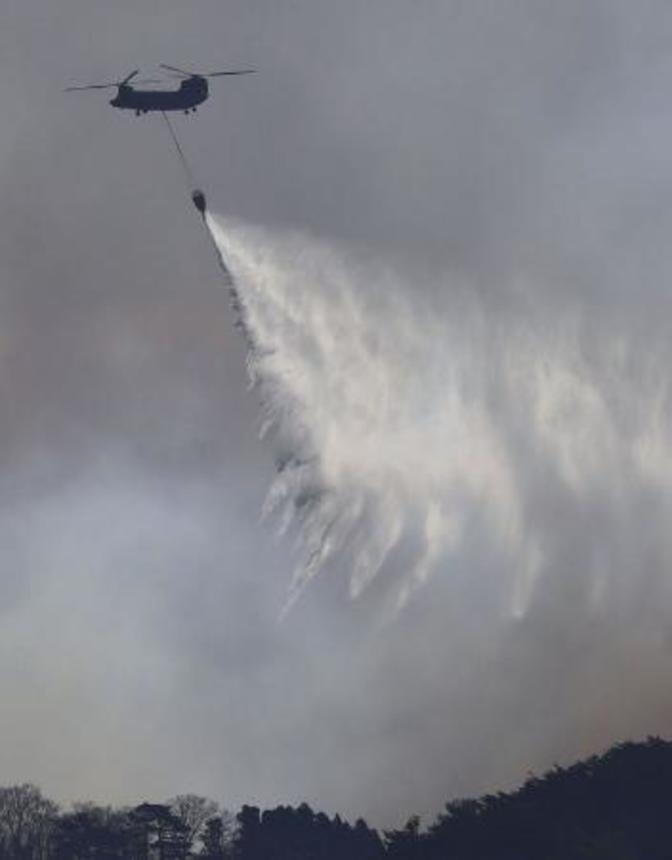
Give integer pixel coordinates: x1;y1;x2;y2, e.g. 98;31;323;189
65;63;256;116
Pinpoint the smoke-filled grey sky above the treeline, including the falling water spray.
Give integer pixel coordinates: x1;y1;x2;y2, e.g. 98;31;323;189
0;0;672;826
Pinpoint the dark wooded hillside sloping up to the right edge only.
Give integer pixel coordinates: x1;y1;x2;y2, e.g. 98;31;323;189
387;738;672;860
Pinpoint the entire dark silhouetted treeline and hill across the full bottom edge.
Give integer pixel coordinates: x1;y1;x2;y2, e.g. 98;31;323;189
0;738;672;860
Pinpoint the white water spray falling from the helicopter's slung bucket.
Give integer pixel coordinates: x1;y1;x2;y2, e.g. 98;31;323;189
209;212;672;618
